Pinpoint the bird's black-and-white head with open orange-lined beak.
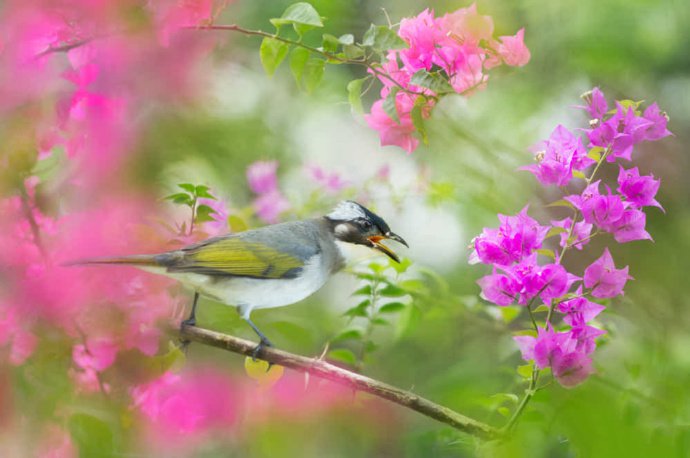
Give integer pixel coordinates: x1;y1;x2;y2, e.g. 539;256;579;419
326;200;408;262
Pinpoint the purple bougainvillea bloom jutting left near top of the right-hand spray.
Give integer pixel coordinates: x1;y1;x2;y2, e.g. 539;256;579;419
520;125;594;186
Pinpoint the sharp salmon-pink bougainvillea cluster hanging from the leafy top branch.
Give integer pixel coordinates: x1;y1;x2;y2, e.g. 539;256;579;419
366;4;530;152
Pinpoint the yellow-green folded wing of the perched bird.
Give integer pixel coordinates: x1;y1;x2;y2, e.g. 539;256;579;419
167;236;308;279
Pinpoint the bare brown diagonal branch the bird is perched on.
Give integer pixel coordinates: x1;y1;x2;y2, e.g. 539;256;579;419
180;326;499;439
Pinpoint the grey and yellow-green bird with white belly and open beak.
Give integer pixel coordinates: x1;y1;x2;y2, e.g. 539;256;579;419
69;200;409;359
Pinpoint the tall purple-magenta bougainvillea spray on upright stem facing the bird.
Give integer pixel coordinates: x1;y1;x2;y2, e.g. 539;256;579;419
470;88;670;387
